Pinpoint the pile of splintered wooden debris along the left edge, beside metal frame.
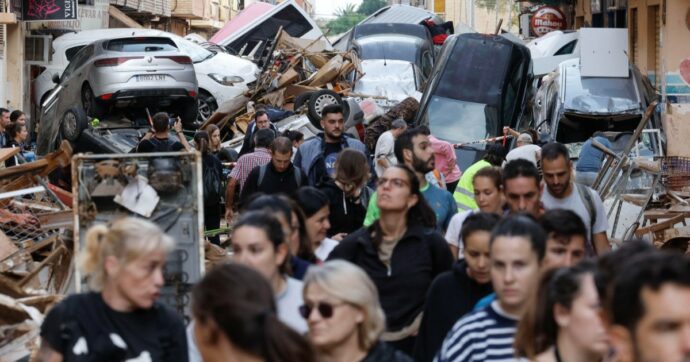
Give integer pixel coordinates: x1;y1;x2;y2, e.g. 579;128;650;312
0;141;74;361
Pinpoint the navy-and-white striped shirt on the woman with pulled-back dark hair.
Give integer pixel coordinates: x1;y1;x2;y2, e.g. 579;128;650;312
434;301;526;362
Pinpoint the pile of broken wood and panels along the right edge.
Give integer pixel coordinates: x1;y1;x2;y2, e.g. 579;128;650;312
593;101;690;254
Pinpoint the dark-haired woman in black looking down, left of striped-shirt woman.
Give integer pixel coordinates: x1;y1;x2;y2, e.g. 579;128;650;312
414;213;500;362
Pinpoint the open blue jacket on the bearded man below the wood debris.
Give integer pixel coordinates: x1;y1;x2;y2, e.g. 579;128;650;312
292;132;369;186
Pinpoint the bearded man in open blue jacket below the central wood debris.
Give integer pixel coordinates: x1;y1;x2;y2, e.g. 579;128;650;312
293;104;367;186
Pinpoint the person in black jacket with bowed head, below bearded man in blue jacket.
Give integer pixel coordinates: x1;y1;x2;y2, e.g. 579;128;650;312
320;149;374;240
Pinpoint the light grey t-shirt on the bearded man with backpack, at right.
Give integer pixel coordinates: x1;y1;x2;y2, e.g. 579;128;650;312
541;184;609;256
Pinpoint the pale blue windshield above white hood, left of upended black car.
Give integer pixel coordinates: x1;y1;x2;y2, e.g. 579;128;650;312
357;35;420;63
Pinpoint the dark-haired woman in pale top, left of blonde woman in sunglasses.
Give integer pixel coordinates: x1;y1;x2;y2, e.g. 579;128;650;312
232;209;307;333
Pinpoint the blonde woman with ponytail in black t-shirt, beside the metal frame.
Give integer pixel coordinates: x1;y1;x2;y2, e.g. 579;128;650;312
39;217;187;361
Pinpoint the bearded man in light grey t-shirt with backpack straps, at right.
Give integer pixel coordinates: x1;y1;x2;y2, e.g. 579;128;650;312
541;142;611;256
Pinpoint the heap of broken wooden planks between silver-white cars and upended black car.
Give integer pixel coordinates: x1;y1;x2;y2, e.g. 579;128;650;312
201;30;368;134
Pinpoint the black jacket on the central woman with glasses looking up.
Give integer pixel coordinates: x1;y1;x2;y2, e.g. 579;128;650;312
328;226;453;331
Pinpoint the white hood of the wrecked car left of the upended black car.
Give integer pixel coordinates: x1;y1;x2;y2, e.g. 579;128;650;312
354;59;422;102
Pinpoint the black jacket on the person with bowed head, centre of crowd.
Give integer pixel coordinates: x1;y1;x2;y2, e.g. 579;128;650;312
319;179;374;237
